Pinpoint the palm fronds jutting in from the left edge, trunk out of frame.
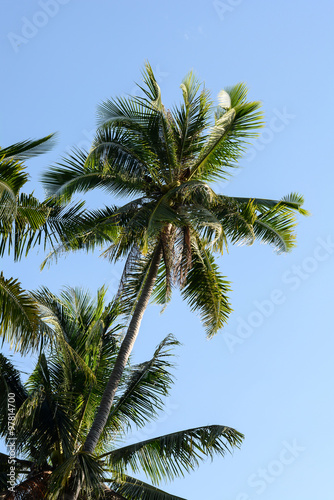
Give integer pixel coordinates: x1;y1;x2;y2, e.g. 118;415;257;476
0;135;82;354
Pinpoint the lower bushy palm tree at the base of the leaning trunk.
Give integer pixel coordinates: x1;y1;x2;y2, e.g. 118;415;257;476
0;288;243;500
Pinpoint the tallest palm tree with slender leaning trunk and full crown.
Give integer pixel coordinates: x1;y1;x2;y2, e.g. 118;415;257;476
43;64;306;462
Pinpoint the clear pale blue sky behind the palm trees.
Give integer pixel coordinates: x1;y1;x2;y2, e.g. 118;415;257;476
0;0;334;500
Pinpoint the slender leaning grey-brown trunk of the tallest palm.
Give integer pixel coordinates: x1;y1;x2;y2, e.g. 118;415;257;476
66;243;162;500
